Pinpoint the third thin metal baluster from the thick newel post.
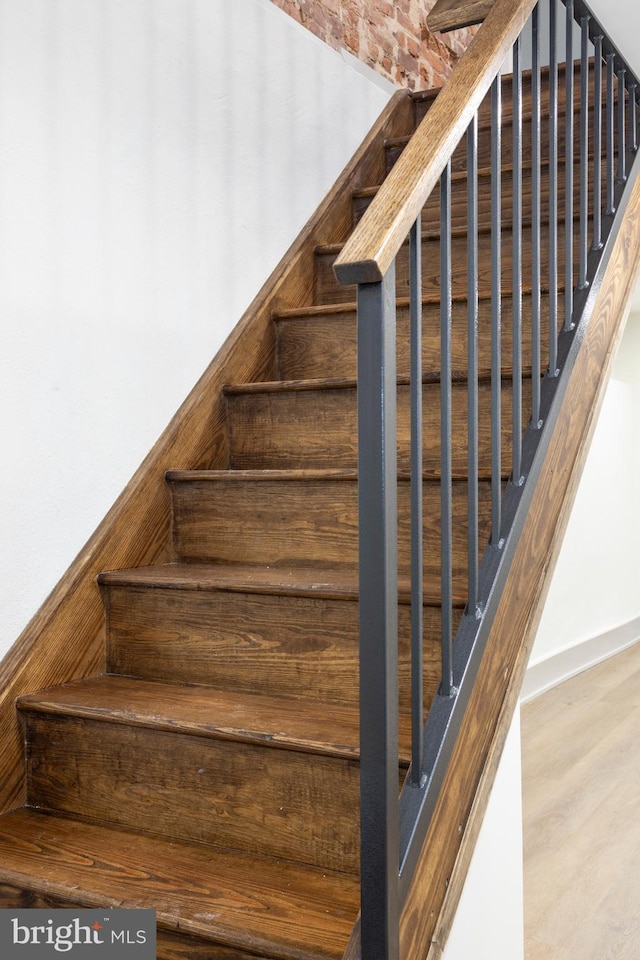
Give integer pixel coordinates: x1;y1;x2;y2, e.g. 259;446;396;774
467;114;478;616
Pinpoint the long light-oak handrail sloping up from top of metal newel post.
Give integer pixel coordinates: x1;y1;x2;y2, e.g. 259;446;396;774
334;0;536;284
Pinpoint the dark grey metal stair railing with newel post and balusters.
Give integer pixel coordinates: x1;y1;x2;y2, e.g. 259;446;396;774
337;0;640;960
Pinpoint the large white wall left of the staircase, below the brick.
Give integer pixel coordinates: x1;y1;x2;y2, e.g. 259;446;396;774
0;0;391;655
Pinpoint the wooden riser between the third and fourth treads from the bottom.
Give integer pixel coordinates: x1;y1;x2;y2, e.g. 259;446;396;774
169;471;491;576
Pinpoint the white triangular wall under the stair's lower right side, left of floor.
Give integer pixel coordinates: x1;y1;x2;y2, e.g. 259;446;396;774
443;710;524;960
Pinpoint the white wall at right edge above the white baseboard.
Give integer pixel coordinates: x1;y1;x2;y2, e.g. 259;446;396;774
530;313;640;667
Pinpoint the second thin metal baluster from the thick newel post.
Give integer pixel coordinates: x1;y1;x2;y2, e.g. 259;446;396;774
440;161;454;697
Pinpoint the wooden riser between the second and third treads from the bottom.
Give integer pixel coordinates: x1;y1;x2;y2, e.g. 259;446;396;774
103;585;448;715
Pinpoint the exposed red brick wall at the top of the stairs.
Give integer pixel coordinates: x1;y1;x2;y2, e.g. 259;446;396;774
272;0;475;90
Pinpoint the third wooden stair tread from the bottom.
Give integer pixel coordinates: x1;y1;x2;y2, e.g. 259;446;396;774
98;563;466;607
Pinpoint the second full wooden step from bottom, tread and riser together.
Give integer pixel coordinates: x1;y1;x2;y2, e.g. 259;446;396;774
21;677;359;873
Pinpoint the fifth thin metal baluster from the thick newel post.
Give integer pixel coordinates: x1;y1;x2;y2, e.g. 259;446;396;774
512;37;522;485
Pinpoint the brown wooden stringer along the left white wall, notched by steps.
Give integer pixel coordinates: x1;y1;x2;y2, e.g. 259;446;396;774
0;92;413;811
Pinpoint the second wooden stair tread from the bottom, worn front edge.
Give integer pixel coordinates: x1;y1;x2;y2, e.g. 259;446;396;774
18;674;382;759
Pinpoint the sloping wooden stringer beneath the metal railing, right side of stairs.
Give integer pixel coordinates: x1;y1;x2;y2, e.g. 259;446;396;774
402;154;640;960
